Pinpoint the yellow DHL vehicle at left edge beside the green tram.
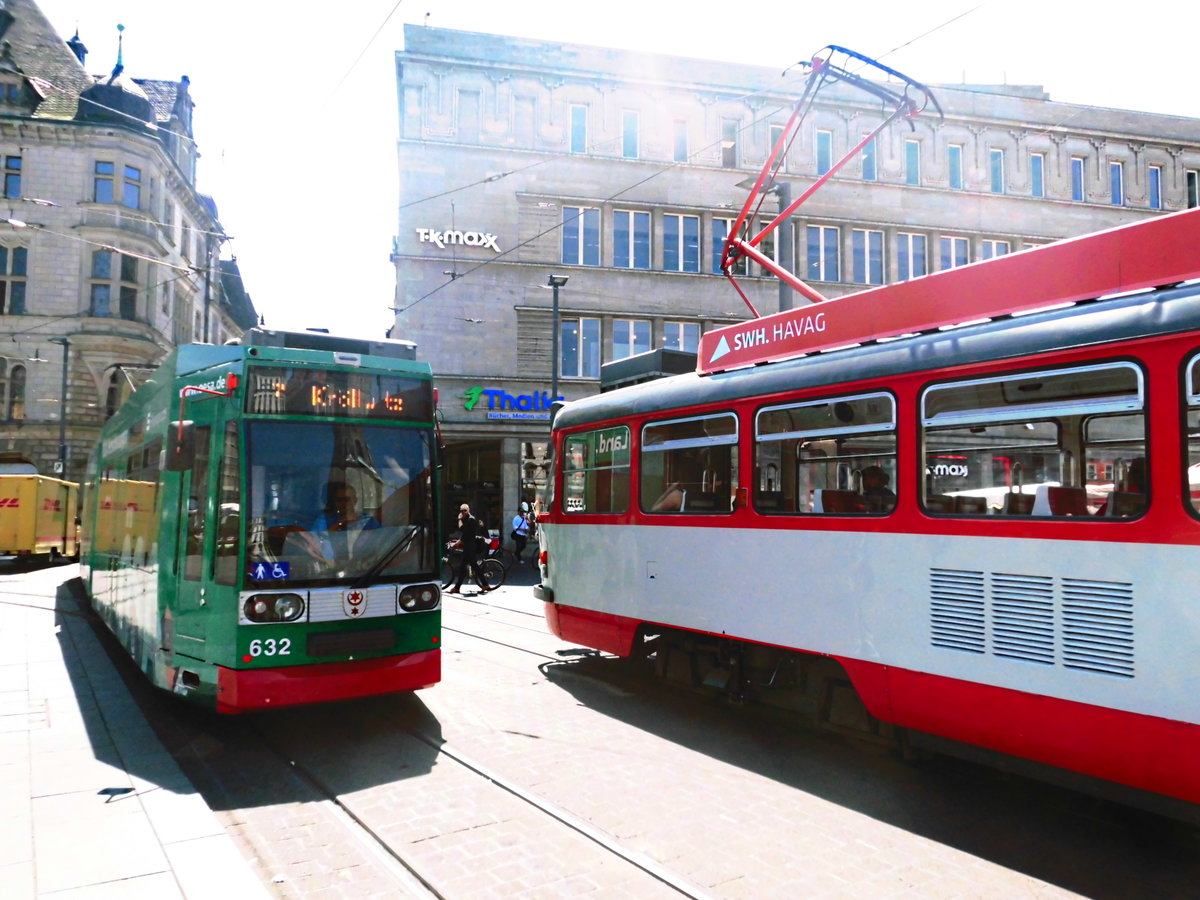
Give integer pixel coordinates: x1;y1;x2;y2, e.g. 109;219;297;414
0;475;79;562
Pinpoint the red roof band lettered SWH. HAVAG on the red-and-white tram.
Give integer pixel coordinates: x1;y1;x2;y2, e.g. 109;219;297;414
696;209;1200;374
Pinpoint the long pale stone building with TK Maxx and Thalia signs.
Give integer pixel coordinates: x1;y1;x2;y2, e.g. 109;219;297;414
392;26;1200;532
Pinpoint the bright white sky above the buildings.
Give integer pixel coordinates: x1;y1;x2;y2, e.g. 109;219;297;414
38;0;1200;337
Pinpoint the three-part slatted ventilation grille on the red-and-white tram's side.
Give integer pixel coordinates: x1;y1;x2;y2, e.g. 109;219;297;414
930;569;1134;678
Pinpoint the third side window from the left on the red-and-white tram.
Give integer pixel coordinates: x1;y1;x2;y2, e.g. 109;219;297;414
754;392;896;515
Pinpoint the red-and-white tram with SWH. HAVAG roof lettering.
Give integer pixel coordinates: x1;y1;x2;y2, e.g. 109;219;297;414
538;210;1200;804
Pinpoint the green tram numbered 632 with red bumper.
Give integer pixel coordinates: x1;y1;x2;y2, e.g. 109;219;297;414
82;329;442;713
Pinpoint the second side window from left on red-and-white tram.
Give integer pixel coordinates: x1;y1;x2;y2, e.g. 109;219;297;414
638;413;738;515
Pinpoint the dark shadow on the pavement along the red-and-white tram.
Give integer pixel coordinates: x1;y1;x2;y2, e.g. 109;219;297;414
541;655;1200;899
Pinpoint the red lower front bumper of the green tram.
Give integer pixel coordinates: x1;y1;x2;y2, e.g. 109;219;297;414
217;649;442;713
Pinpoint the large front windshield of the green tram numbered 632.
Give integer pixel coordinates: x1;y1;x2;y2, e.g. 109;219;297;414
237;420;440;588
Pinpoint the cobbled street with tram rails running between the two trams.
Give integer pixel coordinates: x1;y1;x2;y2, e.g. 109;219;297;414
51;571;1200;900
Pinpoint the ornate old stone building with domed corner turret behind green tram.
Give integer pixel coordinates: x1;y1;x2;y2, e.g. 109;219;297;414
0;0;256;480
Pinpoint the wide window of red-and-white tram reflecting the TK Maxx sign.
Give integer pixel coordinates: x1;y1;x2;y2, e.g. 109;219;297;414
922;362;1146;517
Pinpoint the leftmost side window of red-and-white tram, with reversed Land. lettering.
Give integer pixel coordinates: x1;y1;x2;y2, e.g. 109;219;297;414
563;425;630;514
